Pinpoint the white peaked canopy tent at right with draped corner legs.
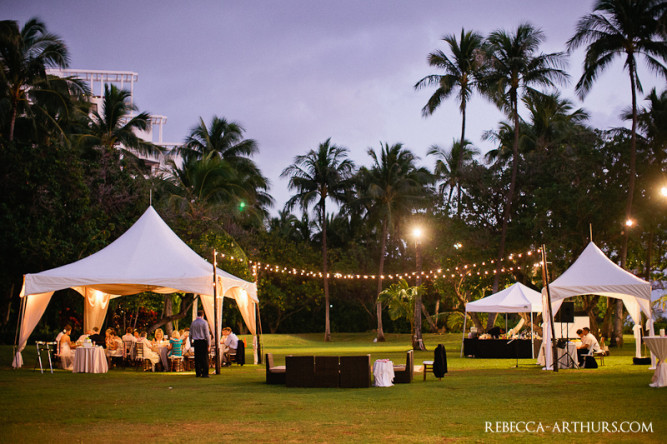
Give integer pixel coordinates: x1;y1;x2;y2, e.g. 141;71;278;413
542;242;655;369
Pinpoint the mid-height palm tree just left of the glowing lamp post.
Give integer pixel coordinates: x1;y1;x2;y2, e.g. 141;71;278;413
358;143;432;341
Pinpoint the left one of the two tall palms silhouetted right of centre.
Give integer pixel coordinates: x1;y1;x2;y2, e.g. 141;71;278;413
415;29;484;170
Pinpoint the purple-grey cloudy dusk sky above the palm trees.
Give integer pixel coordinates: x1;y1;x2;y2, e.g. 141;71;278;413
6;0;664;213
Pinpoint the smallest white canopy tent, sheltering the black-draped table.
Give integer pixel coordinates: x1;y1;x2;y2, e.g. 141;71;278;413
461;282;542;357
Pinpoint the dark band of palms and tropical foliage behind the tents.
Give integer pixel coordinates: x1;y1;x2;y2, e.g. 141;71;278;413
0;12;667;348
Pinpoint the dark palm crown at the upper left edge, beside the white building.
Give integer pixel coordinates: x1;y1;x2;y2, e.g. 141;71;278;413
0;18;69;142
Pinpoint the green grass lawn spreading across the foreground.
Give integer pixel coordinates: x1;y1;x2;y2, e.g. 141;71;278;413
0;333;667;443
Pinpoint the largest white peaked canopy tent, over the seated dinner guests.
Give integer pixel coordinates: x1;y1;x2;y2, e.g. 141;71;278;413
12;206;258;368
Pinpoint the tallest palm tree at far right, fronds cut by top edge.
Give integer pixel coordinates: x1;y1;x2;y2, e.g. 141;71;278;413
567;0;667;268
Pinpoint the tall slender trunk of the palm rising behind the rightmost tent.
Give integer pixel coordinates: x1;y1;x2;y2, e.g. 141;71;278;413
610;60;637;347
